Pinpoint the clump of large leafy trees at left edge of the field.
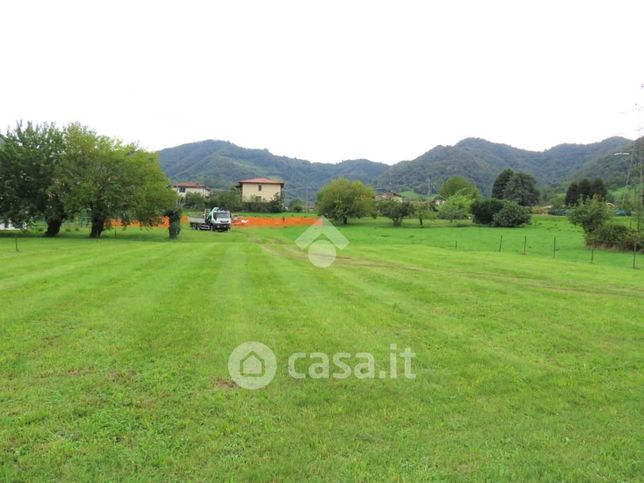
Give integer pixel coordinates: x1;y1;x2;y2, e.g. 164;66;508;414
0;123;177;238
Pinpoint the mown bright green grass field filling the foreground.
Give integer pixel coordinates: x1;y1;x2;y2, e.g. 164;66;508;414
0;217;644;481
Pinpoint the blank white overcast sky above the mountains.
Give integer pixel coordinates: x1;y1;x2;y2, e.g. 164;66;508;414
0;0;644;164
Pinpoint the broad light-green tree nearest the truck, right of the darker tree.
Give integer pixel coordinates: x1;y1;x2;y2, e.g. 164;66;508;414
59;124;176;238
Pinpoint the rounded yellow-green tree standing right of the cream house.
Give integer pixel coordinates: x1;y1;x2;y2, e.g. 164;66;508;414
317;178;374;225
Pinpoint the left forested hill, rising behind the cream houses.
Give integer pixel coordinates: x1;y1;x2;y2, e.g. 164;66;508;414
159;140;389;199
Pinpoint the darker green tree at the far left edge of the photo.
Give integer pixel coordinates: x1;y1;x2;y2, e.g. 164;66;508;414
0;123;66;236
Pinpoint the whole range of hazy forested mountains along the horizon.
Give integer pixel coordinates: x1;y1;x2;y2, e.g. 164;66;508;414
159;137;633;200
